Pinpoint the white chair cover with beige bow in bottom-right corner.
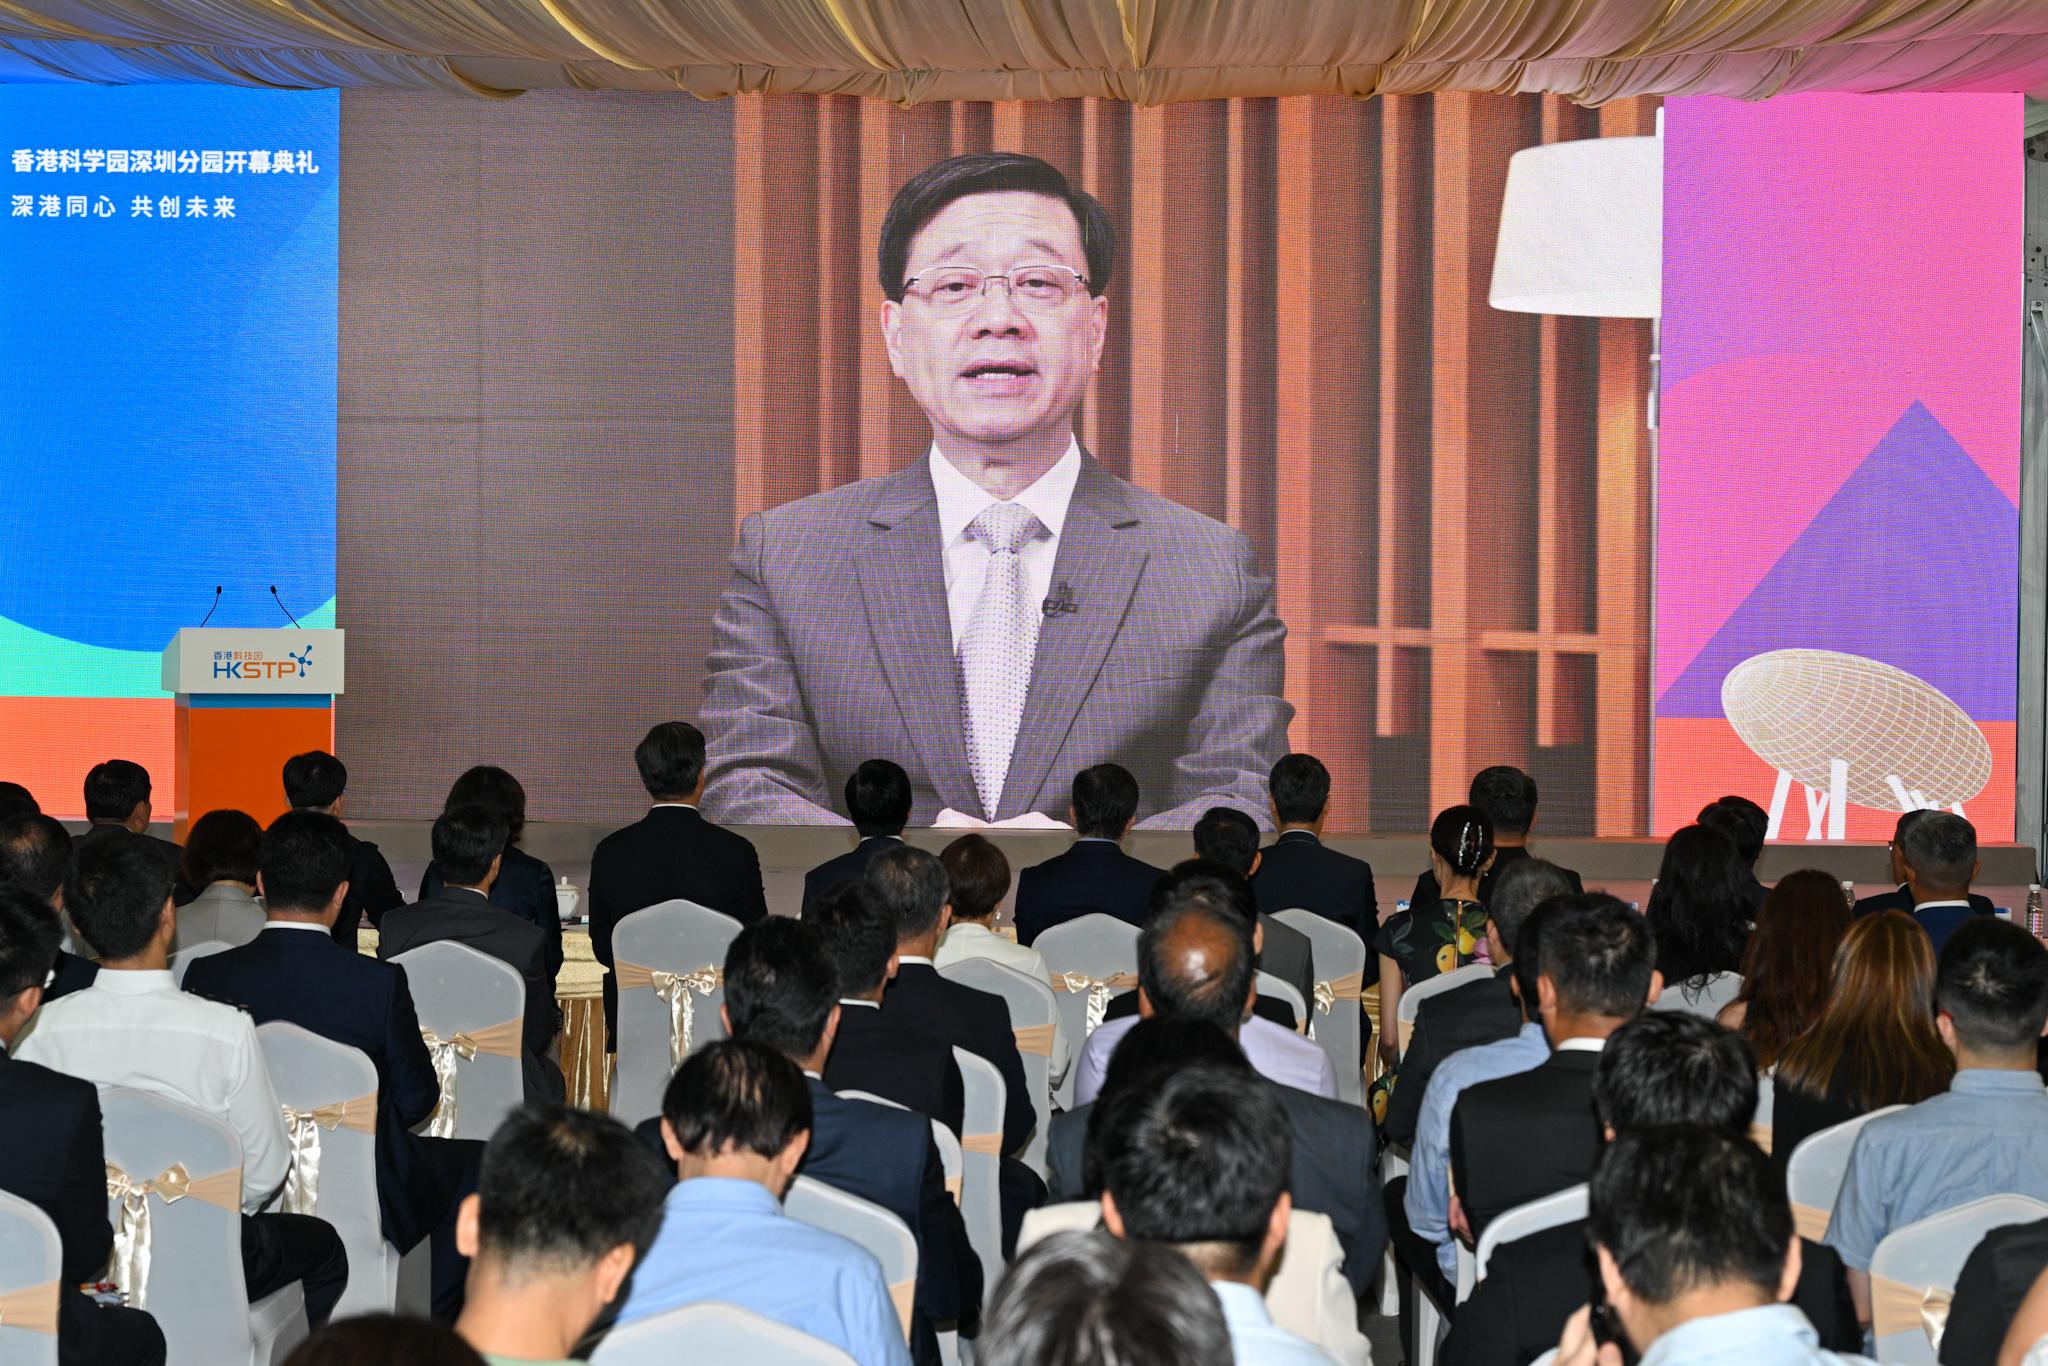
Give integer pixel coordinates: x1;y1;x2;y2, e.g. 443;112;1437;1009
1870;1196;2048;1366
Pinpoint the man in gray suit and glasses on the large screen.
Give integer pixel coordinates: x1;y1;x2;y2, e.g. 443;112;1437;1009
702;154;1292;827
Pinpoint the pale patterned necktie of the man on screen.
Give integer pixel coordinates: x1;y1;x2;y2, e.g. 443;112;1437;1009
961;502;1040;819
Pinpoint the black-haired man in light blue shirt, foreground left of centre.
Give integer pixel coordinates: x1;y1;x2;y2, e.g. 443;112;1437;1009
618;1038;909;1366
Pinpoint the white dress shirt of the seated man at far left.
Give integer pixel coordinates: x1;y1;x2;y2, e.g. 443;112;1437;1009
14;967;291;1214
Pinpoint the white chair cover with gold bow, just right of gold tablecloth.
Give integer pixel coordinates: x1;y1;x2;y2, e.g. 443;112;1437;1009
612;901;739;1124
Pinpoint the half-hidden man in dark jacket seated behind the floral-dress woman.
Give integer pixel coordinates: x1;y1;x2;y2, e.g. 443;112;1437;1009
1380;858;1571;1145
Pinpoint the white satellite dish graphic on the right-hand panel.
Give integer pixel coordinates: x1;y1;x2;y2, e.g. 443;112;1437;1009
1720;649;1991;840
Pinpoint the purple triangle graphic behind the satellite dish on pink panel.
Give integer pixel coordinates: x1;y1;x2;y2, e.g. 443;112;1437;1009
1657;403;2019;721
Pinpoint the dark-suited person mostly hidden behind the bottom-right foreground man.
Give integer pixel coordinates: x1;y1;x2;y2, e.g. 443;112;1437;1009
1442;1010;1864;1366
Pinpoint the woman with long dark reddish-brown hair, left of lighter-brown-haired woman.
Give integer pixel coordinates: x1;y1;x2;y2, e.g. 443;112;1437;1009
1720;876;1851;1069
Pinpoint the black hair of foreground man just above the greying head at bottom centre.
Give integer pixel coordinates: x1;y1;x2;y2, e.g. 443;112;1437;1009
1087;1067;1294;1276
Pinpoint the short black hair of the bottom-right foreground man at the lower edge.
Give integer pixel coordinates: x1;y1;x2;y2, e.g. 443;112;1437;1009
1587;1126;1792;1310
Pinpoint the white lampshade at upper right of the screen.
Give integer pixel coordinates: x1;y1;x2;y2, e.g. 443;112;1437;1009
1487;137;1663;317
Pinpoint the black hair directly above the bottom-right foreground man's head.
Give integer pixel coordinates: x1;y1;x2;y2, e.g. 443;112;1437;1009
1593;1010;1757;1139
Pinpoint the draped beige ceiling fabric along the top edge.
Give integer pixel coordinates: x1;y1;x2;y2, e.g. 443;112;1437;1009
0;0;2048;104
